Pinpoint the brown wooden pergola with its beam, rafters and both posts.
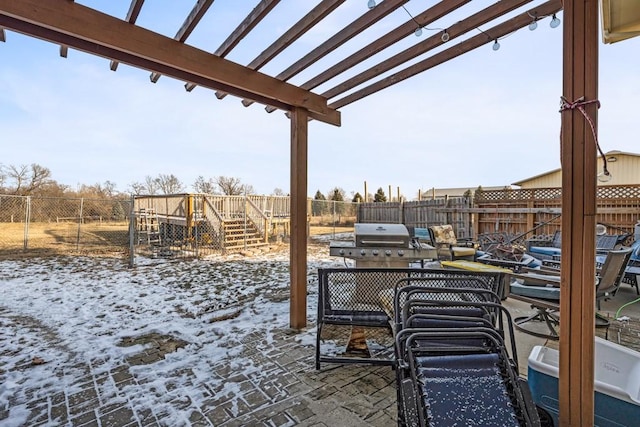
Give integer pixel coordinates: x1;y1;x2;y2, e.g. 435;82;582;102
0;0;640;426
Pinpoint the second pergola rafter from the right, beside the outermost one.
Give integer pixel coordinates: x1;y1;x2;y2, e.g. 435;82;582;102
324;0;531;99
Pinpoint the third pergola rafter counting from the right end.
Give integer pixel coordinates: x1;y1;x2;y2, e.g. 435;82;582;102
300;0;471;90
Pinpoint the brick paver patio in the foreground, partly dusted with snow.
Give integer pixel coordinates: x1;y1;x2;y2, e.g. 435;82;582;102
0;309;396;427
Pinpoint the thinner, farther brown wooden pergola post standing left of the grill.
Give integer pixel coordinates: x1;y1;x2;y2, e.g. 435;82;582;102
289;108;308;329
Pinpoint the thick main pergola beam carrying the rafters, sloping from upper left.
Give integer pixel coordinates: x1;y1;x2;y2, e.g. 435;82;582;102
0;0;340;125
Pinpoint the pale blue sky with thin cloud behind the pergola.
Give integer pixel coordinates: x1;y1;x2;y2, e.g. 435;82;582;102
0;0;640;199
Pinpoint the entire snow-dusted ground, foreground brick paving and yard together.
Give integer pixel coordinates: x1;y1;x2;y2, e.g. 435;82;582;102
0;245;396;426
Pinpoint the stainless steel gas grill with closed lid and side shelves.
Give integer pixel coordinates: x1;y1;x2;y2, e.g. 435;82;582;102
329;224;438;268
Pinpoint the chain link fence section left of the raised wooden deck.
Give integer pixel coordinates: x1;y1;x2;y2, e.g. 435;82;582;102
0;195;131;257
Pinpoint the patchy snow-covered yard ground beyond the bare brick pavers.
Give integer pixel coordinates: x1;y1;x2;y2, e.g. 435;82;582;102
0;243;356;426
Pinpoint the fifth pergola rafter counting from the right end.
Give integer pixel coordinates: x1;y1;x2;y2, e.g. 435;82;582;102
216;0;346;99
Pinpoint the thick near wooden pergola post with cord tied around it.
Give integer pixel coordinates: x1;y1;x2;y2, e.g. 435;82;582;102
559;0;598;426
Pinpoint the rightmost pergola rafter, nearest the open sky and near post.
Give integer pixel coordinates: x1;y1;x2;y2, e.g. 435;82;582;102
330;0;562;109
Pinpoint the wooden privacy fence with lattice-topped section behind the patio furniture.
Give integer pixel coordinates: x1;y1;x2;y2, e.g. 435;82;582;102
357;185;640;242
